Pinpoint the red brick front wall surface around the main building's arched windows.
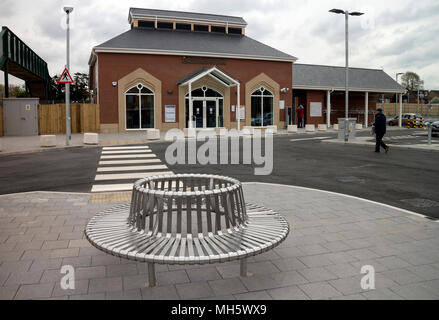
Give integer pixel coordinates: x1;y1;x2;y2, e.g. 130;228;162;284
98;53;292;124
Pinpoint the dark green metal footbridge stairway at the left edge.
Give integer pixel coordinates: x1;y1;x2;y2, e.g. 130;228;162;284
0;27;53;100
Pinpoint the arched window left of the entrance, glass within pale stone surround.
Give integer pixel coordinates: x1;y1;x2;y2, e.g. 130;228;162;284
125;83;154;130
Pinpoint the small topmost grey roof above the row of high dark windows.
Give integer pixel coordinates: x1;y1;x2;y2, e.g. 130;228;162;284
130;8;247;26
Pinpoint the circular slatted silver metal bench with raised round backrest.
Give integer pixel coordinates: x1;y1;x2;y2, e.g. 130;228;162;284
85;174;289;286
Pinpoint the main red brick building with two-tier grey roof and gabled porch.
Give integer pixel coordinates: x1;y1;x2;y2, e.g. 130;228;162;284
89;8;297;132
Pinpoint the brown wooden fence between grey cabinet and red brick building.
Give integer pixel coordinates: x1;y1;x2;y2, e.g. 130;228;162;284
38;103;100;135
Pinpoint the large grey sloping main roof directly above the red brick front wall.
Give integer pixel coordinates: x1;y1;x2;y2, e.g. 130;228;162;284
95;28;296;61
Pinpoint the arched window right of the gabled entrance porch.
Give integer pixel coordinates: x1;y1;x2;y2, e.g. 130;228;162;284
251;87;274;127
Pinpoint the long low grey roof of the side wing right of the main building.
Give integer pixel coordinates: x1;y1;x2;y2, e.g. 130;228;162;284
293;63;405;92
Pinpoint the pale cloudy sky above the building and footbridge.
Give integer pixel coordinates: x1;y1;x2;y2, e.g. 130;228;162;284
0;0;439;89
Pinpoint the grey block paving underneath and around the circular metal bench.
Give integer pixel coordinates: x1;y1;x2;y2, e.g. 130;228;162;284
0;183;439;300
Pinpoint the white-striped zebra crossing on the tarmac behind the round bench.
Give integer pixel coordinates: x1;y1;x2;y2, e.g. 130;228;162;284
91;146;173;193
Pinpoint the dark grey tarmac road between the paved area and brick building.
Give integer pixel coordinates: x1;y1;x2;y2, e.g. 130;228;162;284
0;131;439;219
